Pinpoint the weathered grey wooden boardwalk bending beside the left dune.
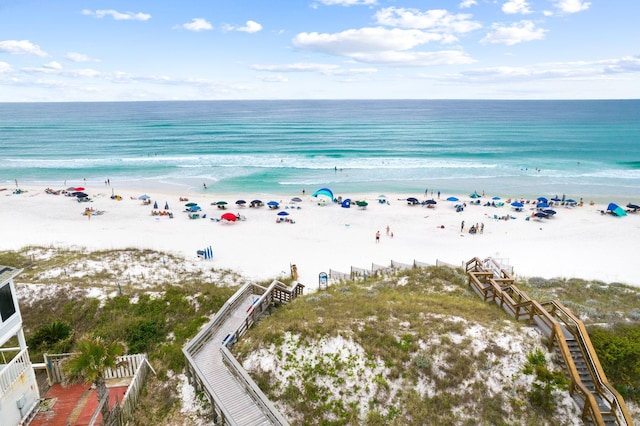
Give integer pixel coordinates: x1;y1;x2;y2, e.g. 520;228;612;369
182;280;304;426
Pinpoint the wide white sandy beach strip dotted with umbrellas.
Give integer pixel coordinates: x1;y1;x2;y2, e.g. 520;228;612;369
0;183;640;291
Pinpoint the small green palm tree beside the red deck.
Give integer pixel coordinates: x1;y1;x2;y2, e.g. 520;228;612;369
64;336;125;419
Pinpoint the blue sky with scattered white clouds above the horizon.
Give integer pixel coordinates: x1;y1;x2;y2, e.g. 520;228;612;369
0;0;640;102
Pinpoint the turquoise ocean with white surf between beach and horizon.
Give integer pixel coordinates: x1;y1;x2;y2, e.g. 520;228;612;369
0;100;640;203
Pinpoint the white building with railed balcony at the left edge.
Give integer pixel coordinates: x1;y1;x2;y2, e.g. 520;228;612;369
0;265;40;426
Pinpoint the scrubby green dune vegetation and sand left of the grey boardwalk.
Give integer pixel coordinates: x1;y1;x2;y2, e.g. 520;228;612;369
0;247;237;424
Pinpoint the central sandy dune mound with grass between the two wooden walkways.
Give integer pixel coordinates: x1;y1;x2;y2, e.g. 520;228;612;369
233;267;562;425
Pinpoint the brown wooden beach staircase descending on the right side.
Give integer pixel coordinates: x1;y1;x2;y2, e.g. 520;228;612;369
465;257;633;426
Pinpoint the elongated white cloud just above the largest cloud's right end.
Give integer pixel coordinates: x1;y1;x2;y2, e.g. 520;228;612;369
375;7;482;33
